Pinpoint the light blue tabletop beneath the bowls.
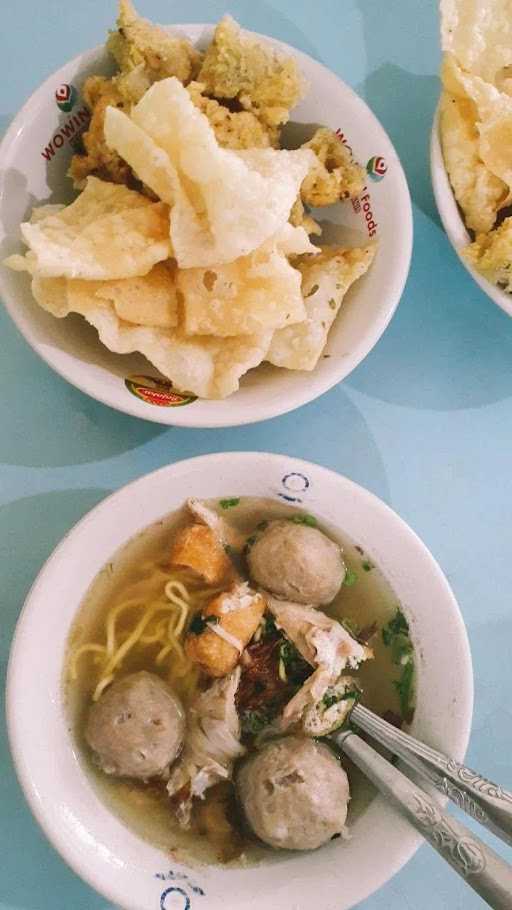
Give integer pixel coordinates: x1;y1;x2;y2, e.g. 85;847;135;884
0;0;512;910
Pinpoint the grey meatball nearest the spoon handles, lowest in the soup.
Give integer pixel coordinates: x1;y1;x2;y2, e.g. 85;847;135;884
237;736;350;850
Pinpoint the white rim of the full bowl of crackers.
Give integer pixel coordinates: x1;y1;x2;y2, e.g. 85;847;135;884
0;23;413;429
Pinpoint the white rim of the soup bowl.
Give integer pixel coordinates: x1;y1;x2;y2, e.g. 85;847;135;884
6;452;473;910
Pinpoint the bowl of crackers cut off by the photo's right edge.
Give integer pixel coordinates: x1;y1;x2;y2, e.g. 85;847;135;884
431;0;512;315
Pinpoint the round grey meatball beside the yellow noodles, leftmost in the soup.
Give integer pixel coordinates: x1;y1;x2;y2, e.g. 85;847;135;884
85;671;185;780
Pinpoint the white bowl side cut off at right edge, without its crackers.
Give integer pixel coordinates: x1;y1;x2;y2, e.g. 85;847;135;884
430;109;512;316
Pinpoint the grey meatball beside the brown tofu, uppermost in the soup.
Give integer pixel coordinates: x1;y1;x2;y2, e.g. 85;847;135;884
247;520;346;607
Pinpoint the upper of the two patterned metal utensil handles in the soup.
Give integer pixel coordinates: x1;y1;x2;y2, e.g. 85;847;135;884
351;705;512;848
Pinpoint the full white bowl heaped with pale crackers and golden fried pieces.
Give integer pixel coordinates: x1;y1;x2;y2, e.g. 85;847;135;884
0;0;412;427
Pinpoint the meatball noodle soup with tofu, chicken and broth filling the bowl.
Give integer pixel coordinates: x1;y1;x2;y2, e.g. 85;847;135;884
65;497;414;863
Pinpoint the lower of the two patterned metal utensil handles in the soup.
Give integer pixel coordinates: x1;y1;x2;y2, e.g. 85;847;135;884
335;730;512;910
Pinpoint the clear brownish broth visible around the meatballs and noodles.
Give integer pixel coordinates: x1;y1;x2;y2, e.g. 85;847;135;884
64;497;412;864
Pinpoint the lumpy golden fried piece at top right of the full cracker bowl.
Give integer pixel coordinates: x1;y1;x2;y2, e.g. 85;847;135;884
197;16;302;127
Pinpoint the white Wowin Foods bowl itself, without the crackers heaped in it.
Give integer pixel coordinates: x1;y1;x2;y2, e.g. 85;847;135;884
0;25;412;427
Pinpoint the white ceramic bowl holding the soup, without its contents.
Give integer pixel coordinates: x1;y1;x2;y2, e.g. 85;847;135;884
7;452;473;910
